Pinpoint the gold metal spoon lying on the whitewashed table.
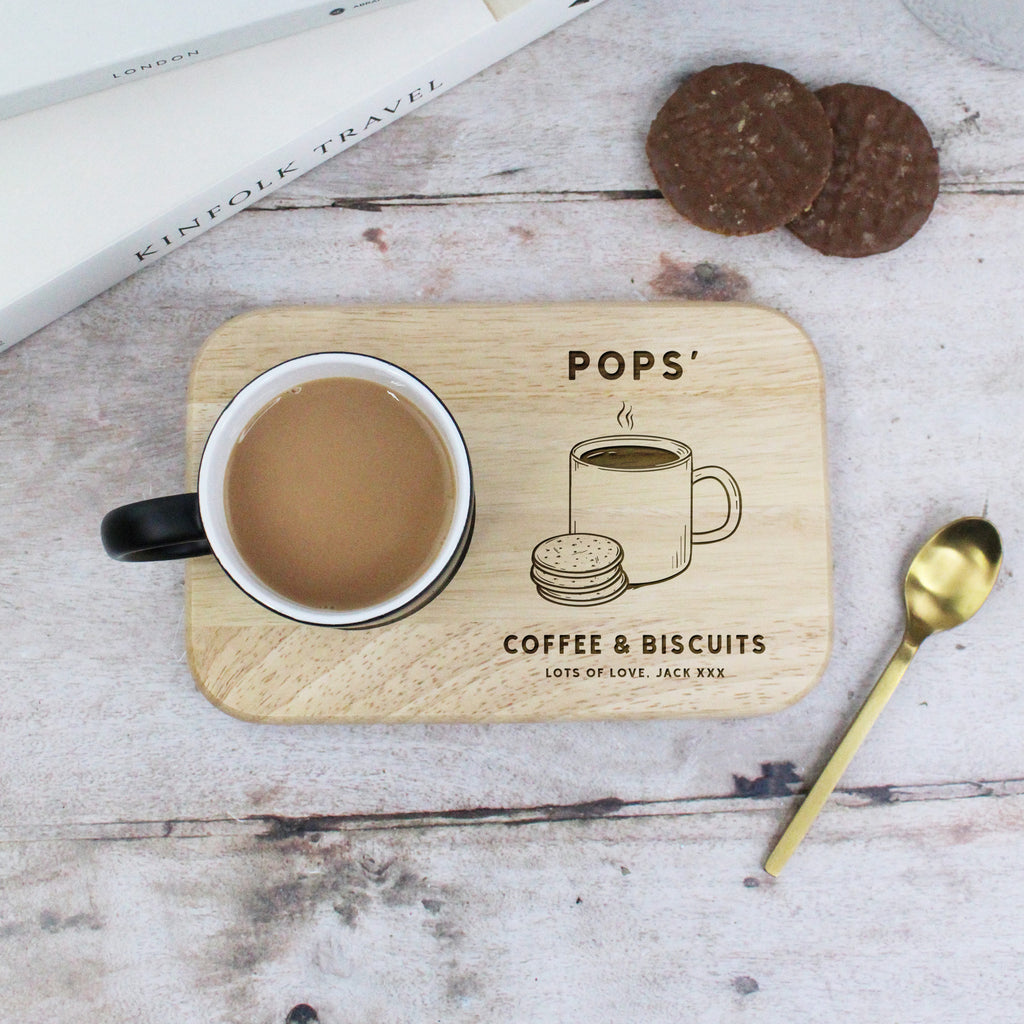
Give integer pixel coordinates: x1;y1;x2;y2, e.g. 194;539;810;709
765;517;1002;874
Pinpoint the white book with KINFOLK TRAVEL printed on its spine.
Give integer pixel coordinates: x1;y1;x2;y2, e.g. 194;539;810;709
0;0;600;350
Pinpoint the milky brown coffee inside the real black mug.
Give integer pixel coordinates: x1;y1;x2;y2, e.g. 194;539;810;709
230;377;455;611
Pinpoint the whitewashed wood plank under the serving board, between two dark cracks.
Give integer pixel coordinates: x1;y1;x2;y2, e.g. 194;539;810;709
0;196;1024;836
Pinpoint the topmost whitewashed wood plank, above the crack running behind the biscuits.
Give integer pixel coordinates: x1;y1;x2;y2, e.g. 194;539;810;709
263;0;1024;208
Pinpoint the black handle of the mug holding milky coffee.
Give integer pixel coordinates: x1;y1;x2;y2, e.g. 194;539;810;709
99;494;212;562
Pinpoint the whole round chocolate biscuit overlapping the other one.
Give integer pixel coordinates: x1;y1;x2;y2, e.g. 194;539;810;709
647;63;833;234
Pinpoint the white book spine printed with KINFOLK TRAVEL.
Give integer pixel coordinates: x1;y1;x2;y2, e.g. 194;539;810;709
0;0;602;351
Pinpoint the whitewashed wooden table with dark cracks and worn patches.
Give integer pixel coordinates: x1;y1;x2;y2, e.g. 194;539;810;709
0;0;1024;1024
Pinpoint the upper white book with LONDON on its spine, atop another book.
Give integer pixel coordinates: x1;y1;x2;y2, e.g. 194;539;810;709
0;0;415;118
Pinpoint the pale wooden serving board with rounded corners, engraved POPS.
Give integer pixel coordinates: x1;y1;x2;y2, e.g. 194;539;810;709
185;302;831;723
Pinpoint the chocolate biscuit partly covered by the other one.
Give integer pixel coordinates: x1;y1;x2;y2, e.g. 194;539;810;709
788;83;939;256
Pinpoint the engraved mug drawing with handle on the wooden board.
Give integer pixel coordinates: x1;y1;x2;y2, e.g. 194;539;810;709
569;434;741;588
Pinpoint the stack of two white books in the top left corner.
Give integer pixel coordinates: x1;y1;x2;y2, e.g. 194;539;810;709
0;0;601;350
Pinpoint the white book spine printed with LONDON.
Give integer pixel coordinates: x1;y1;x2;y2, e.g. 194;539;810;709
0;0;409;119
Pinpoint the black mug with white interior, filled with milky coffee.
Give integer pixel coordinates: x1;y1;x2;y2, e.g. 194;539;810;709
102;352;474;627
